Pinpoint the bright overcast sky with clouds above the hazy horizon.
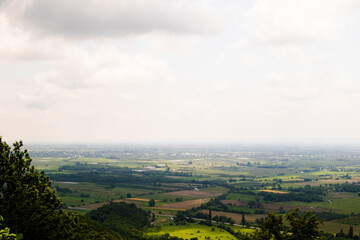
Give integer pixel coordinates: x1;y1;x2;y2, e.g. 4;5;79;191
0;0;360;145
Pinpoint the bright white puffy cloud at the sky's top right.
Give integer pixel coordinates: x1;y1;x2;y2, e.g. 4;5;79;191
248;0;342;44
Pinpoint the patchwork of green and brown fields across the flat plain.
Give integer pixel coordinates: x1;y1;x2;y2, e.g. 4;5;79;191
28;144;360;239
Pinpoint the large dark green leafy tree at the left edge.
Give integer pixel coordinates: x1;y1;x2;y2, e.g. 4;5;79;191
0;137;77;240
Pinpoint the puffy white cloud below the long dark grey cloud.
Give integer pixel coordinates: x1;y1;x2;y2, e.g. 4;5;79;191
19;46;170;109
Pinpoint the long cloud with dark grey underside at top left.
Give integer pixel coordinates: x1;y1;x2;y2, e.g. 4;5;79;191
4;0;219;38
